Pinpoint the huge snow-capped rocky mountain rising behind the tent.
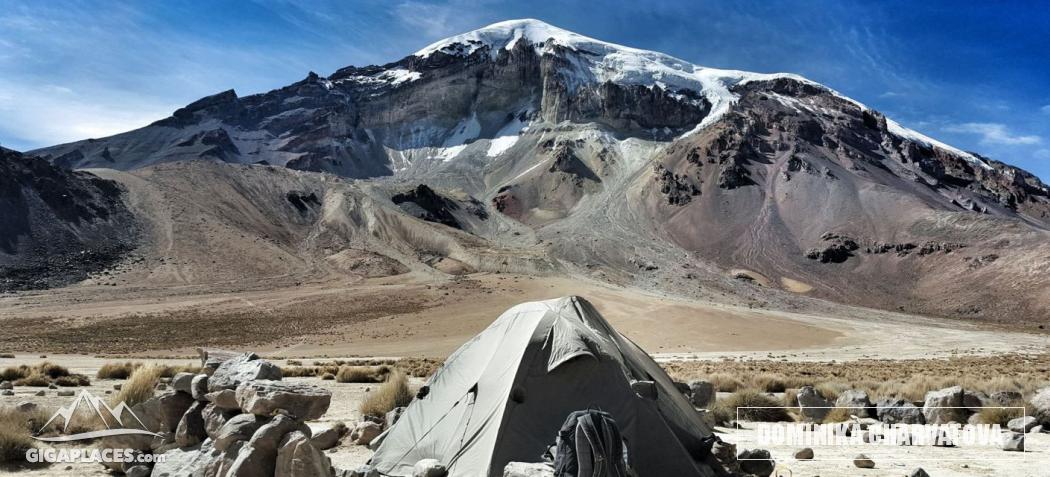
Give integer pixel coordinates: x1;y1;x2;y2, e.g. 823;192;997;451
16;20;1050;319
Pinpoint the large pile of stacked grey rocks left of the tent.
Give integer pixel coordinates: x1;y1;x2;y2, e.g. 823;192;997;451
103;353;339;477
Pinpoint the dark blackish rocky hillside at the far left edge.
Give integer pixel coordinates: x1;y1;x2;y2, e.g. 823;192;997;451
0;148;139;292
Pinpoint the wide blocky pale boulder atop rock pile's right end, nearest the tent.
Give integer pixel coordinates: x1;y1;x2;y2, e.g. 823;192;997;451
236;378;332;420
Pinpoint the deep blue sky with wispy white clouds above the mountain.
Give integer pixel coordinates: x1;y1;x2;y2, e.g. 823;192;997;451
0;0;1050;181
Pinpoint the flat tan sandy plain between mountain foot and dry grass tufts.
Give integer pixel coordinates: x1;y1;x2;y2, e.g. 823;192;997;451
0;274;1050;360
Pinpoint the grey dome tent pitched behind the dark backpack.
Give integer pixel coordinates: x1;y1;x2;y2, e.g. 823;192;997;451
371;296;714;477
